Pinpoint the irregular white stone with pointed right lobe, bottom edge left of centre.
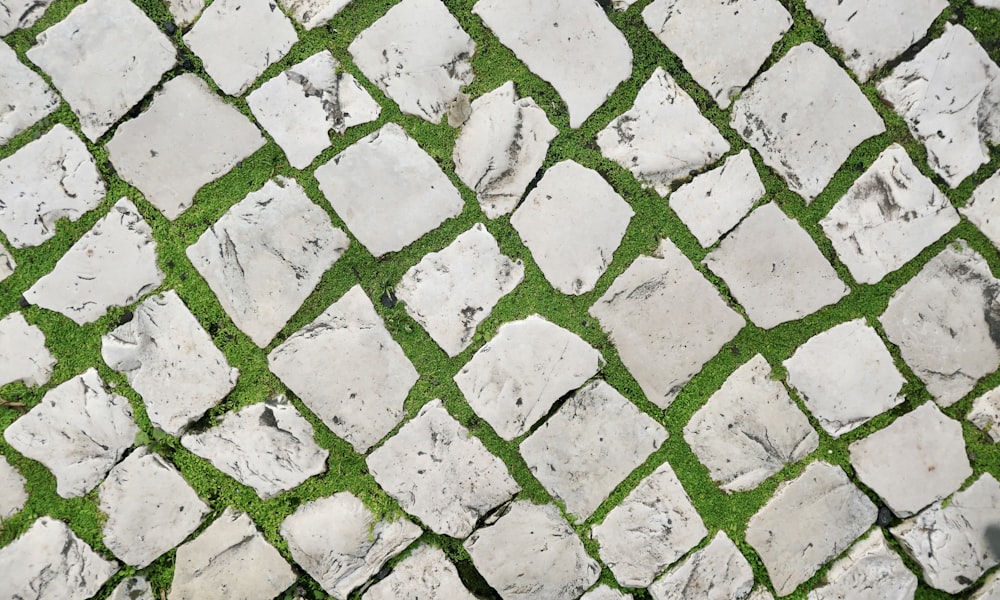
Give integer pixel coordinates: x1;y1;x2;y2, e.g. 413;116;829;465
280;492;422;600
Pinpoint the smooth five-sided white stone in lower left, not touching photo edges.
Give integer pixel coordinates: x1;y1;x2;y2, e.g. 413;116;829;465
97;447;211;569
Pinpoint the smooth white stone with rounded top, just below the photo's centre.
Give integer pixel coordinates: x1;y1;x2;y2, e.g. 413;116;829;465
455;315;604;441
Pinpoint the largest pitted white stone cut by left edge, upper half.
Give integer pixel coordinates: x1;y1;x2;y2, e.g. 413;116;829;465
0;124;105;248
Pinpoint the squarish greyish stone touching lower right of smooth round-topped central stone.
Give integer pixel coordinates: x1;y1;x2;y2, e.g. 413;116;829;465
520;380;667;521
